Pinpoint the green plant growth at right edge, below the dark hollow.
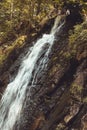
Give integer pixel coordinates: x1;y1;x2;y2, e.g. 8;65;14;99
69;22;87;60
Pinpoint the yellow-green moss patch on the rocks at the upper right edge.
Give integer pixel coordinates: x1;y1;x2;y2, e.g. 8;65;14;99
60;22;87;60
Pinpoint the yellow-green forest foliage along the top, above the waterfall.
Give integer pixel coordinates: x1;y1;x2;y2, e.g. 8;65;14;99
0;0;87;42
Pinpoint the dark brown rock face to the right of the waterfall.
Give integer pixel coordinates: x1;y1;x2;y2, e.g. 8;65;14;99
0;12;87;130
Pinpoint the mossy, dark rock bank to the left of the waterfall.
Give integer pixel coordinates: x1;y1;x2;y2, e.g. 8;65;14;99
0;17;55;98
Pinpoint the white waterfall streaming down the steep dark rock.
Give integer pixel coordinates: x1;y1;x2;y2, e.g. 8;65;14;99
0;15;63;130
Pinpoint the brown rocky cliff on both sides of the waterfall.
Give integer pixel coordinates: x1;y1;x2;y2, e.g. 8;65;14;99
0;4;87;130
